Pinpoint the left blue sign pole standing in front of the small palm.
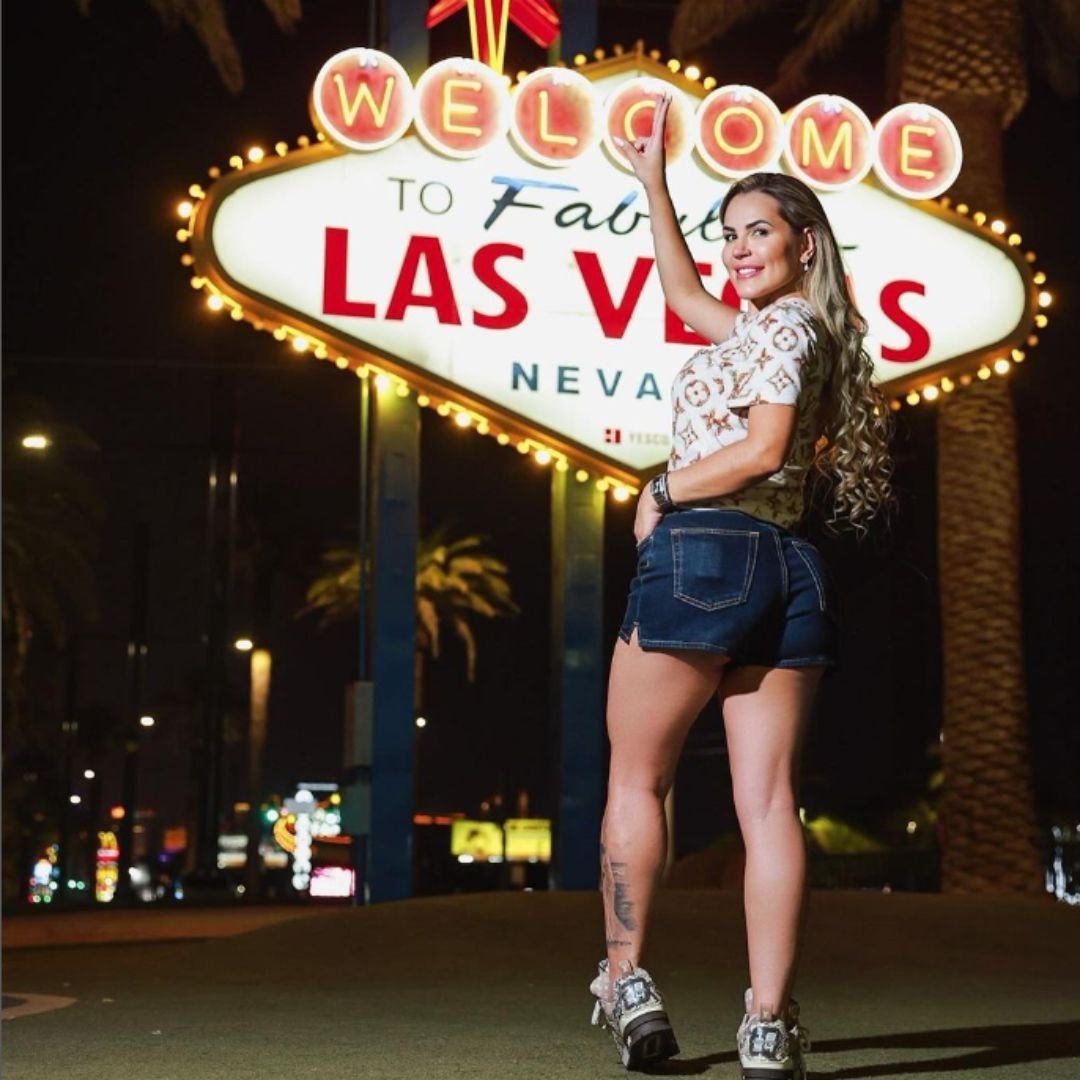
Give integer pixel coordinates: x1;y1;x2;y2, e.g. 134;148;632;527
368;388;420;902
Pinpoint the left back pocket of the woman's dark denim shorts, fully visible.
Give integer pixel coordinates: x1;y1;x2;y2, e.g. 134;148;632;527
672;528;760;611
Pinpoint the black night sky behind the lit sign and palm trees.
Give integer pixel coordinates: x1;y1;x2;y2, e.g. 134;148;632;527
3;0;1080;855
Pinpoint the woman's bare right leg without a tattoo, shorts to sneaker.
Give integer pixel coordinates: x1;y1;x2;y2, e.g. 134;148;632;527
720;667;822;1016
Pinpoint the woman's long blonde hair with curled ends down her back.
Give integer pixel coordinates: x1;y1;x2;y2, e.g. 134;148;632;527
720;173;893;535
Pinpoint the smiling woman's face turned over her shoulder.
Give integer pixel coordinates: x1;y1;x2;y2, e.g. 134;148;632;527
724;191;812;309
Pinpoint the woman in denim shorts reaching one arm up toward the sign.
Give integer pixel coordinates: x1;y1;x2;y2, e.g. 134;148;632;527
591;97;891;1080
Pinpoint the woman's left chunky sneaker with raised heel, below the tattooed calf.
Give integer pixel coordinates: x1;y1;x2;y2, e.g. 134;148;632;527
589;960;678;1069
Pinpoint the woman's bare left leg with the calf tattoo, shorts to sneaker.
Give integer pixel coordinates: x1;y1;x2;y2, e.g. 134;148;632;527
600;632;725;978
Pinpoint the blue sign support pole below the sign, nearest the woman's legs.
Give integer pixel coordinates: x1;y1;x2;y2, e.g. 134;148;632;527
551;471;605;889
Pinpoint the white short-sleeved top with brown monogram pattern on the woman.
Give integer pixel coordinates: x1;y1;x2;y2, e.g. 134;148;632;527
669;296;827;528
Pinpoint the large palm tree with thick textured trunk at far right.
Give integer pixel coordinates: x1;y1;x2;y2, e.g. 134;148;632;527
673;0;1080;893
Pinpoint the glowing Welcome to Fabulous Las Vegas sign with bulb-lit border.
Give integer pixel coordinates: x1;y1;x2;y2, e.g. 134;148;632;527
190;49;1036;483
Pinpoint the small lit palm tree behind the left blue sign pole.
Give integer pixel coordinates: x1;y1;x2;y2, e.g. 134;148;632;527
300;529;519;707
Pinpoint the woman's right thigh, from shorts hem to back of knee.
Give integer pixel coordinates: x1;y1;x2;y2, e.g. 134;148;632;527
719;666;823;818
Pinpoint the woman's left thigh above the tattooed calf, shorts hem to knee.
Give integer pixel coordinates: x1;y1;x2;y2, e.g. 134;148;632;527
607;631;725;794
